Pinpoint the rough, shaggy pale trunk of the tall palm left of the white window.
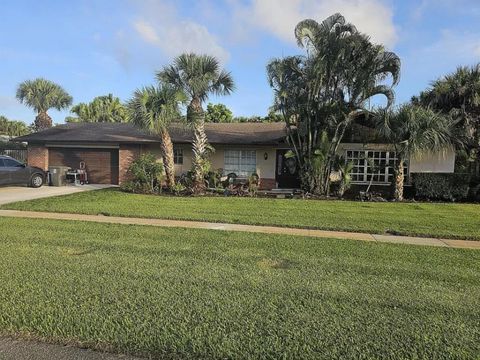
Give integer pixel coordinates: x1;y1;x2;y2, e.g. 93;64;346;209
187;98;208;193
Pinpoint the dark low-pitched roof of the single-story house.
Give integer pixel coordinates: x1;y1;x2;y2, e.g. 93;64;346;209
14;123;286;145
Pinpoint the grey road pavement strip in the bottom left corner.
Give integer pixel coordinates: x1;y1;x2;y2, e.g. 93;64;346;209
0;337;139;360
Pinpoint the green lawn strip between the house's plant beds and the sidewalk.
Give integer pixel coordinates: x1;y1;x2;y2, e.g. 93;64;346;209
3;189;480;240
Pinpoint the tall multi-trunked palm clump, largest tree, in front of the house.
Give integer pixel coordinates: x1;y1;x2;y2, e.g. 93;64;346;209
267;14;400;195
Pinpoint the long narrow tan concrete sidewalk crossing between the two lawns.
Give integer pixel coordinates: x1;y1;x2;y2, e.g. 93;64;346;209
0;210;480;249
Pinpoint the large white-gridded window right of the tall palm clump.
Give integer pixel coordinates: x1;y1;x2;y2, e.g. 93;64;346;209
345;150;408;184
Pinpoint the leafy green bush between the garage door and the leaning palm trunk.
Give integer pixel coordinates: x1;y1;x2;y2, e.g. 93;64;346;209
121;153;163;194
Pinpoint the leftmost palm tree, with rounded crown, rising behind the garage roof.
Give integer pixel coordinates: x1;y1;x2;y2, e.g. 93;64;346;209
17;78;72;131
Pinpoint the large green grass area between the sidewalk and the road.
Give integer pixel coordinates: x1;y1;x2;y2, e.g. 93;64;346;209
0;215;480;359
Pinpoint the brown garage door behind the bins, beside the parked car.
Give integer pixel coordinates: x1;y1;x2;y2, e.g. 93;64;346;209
48;148;118;184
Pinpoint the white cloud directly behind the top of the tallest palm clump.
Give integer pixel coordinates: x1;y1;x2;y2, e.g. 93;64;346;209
236;0;397;47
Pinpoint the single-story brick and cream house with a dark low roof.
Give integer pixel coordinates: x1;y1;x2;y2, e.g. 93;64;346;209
15;123;455;189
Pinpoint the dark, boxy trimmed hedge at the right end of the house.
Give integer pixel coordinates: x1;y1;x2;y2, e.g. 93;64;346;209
413;173;470;201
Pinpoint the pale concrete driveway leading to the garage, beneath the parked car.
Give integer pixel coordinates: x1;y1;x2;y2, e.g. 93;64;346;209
0;184;112;205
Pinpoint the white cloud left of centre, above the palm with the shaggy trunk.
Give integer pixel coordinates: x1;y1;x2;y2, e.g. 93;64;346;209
132;1;230;62
